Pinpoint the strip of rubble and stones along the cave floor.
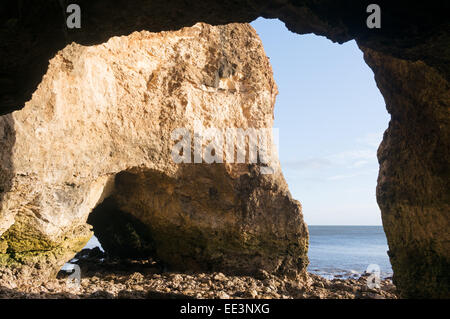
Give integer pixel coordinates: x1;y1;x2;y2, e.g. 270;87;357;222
0;249;397;299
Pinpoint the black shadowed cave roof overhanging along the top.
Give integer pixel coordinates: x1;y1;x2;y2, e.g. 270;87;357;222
0;0;450;114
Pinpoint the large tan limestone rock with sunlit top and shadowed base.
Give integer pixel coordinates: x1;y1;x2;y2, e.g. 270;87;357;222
0;23;308;276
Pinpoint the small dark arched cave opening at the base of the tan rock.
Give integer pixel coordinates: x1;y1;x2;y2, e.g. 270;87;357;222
61;170;164;276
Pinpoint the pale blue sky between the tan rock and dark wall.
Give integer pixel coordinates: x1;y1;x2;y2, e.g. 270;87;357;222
251;18;390;225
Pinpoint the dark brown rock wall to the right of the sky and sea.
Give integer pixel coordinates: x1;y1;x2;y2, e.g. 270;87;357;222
362;48;450;298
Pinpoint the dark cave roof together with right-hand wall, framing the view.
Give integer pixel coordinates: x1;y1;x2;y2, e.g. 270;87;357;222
0;0;450;297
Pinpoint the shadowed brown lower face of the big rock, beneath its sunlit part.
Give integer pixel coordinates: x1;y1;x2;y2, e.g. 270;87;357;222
88;168;308;278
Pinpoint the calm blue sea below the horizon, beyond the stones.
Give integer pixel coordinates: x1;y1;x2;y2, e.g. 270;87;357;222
308;226;392;279
